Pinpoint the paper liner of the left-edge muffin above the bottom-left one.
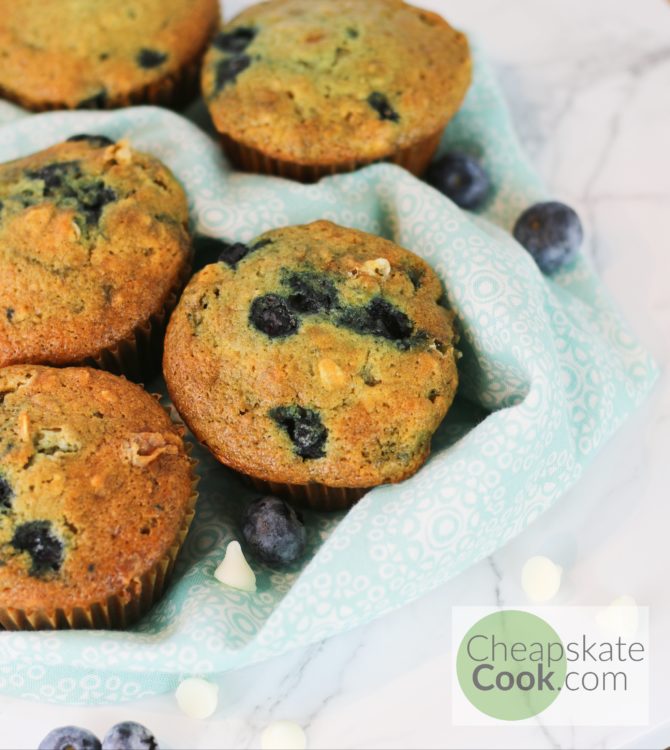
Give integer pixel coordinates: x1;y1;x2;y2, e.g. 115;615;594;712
75;259;191;383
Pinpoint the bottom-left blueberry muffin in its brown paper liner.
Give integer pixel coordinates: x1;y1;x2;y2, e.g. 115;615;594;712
0;365;195;630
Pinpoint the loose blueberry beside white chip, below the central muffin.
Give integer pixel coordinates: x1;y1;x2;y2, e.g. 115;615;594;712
242;496;307;566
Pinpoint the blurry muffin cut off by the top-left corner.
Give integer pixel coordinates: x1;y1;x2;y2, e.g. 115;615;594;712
0;0;219;110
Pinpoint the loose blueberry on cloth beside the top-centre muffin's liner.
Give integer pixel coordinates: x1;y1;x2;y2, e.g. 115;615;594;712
426;152;491;211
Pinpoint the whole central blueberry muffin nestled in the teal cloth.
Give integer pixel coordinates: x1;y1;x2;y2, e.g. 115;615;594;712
163;221;458;509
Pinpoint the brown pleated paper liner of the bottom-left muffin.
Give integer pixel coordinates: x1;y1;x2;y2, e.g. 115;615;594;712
0;443;200;630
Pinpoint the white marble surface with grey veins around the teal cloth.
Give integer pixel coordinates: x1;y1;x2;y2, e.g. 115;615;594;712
0;0;670;749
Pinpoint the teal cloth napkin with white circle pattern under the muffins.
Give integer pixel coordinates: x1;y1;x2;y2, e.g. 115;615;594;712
0;47;657;704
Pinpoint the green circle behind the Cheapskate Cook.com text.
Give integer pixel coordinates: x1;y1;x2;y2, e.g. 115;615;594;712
456;609;567;721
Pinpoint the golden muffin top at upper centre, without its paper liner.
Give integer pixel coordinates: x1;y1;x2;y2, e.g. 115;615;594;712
203;0;471;165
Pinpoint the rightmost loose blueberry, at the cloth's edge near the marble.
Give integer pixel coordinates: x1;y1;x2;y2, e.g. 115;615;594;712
514;201;584;273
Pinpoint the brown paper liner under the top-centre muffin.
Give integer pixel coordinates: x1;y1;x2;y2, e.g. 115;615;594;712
221;128;444;182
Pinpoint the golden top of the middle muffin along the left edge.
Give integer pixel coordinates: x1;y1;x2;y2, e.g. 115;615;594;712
0;136;191;367
